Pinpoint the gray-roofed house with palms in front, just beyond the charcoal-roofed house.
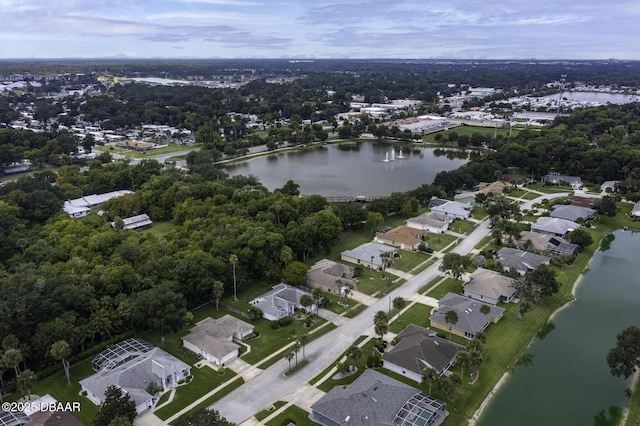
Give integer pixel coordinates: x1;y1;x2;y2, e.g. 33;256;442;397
430;293;504;339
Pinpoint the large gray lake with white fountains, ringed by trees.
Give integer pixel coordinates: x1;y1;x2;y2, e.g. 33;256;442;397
225;142;470;195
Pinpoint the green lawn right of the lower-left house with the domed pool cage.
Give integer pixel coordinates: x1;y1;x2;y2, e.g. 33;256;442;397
155;366;236;420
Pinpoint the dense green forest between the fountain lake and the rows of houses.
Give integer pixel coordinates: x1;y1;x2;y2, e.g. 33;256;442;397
0;104;640;382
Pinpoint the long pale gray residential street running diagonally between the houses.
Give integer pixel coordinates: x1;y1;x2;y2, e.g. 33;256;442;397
209;193;568;424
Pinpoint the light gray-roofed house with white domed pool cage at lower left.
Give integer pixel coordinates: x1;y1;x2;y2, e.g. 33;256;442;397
80;339;191;413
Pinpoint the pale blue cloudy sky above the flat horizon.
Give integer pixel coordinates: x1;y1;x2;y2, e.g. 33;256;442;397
0;0;640;59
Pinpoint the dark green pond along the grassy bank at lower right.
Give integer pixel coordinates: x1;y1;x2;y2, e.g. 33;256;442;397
476;231;640;426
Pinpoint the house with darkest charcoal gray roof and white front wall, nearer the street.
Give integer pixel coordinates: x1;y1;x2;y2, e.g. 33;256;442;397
383;324;465;383
